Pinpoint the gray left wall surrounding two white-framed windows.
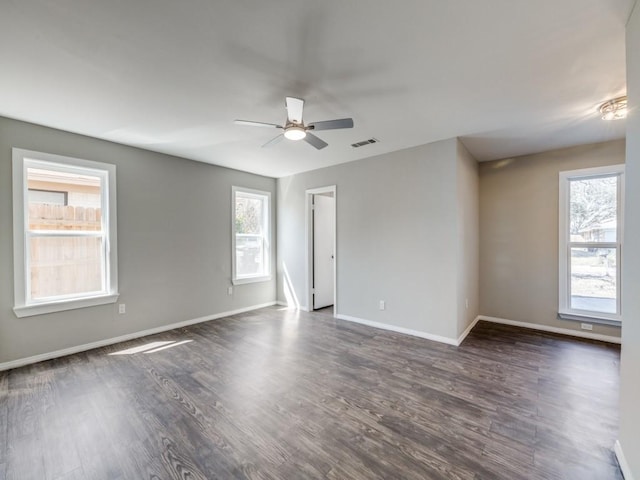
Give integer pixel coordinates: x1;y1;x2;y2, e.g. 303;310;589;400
0;118;276;363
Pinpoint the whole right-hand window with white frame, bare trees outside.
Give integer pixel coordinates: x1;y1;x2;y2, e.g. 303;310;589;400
559;165;624;324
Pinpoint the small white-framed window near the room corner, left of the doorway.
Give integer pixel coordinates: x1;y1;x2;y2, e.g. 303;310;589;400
232;187;271;284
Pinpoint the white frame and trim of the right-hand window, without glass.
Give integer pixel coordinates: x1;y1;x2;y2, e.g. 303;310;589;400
558;165;624;325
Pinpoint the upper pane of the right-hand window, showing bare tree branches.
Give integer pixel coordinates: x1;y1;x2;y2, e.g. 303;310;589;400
569;176;618;242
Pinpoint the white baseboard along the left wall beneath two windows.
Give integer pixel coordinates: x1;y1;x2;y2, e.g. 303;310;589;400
0;302;276;372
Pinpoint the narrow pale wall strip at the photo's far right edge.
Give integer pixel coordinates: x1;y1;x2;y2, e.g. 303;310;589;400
619;3;640;479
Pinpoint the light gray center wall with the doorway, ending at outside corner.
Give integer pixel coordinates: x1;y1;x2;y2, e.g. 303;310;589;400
278;139;477;339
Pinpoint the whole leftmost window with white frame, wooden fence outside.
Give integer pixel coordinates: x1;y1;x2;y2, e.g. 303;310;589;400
13;148;118;317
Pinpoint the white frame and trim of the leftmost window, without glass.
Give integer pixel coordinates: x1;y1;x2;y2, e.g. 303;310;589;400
12;148;118;317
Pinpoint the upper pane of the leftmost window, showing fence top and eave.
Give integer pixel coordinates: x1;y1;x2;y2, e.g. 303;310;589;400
27;168;102;231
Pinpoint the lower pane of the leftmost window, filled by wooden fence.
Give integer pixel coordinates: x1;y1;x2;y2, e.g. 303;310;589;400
30;237;105;300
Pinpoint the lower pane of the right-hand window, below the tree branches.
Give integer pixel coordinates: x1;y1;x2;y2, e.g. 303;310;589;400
570;248;618;314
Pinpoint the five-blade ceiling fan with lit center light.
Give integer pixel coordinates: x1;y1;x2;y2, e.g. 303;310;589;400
235;97;353;150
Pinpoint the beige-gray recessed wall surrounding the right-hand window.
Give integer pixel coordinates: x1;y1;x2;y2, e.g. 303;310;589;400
480;140;626;336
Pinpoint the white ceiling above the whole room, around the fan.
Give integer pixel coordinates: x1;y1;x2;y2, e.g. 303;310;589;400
0;0;634;177
